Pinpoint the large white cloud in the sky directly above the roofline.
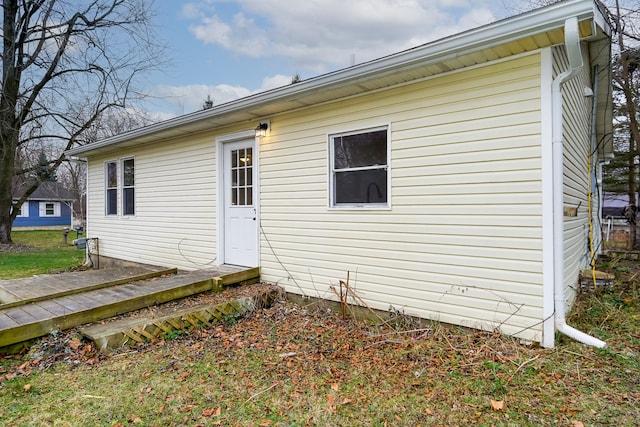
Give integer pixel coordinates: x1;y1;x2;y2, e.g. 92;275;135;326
184;0;495;75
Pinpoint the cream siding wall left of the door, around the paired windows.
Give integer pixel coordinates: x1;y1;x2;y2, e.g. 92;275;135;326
87;135;222;269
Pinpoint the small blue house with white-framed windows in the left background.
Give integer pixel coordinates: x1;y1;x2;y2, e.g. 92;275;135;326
13;181;74;230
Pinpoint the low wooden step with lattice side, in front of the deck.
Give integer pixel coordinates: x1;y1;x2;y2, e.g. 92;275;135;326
79;286;282;351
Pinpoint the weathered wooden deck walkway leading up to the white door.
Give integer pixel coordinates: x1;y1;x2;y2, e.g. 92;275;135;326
0;266;259;353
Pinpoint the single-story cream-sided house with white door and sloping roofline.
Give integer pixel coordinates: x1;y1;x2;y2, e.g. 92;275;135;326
68;0;612;347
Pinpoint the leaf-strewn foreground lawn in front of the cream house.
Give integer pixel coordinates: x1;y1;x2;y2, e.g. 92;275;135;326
0;261;640;427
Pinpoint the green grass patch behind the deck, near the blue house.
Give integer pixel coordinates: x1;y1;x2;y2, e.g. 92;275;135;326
0;230;84;280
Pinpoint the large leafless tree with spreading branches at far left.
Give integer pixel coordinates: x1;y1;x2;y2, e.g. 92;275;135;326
0;0;162;243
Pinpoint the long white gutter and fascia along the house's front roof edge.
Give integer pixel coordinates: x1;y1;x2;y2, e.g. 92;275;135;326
65;0;608;156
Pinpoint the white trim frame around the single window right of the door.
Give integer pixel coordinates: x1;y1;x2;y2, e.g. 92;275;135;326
327;123;391;211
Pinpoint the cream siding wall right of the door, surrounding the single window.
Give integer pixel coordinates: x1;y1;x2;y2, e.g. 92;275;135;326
260;54;543;340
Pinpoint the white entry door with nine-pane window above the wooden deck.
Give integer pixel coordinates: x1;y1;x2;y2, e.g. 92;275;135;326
223;139;259;267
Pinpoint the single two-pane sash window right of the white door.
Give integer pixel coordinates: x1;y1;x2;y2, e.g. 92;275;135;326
330;126;389;207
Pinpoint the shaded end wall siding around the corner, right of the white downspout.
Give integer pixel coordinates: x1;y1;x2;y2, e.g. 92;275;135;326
553;46;600;305
